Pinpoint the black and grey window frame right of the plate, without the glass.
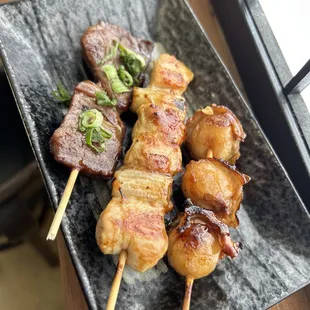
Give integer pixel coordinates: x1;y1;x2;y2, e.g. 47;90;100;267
211;0;310;209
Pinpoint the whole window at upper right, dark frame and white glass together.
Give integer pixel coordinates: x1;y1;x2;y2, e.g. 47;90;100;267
211;0;310;210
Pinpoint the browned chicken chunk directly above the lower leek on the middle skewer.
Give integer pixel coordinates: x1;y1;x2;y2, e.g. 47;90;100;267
124;135;182;176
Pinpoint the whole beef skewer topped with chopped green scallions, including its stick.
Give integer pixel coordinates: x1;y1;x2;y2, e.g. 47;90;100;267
47;22;153;240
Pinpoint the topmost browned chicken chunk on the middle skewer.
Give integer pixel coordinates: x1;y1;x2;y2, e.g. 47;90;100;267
149;54;194;95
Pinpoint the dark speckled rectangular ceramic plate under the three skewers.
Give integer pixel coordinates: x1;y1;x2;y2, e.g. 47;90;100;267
0;0;310;309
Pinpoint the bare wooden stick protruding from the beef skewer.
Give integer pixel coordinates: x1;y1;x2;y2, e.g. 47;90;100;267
46;169;79;240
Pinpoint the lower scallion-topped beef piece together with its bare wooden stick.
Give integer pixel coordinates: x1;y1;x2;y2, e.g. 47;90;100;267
47;81;124;240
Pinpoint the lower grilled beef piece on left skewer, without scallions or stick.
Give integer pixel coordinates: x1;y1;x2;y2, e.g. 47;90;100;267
50;81;125;177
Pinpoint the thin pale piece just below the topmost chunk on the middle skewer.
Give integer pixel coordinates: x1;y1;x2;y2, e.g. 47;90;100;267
130;87;186;114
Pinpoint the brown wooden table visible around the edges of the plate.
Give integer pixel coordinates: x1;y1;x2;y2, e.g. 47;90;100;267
57;0;310;310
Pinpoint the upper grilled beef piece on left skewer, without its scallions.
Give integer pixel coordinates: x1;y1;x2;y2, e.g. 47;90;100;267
81;22;154;111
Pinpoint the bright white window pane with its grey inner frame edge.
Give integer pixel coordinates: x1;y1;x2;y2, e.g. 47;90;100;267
243;0;310;151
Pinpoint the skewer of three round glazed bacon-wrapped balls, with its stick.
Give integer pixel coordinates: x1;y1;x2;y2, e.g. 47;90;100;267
168;105;250;310
